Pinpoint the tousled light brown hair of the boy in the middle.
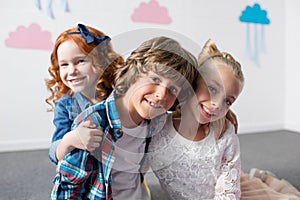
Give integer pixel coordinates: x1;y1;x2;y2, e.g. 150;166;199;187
115;36;198;99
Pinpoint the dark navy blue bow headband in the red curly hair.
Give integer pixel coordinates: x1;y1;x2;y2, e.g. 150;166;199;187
67;24;111;50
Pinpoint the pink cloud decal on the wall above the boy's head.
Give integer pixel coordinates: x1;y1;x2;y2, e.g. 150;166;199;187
131;0;172;24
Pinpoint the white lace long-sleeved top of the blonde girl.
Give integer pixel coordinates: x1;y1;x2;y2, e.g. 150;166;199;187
146;115;241;200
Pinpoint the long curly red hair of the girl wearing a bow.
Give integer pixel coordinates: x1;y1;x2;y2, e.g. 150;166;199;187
45;26;124;111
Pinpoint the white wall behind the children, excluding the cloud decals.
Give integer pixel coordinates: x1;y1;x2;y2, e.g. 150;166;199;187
0;0;294;151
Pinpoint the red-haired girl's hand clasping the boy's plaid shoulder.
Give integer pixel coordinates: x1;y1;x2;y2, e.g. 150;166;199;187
75;121;103;154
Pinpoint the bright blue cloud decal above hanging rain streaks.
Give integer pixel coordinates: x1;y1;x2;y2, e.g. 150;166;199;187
240;3;270;24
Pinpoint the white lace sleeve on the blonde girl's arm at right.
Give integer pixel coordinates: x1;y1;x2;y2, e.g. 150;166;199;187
215;133;241;200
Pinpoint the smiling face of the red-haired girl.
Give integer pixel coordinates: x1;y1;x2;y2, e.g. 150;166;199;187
57;40;99;98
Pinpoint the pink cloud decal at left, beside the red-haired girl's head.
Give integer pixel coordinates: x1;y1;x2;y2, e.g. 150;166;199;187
5;23;53;50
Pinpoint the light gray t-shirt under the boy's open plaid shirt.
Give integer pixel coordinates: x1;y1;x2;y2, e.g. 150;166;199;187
112;121;150;200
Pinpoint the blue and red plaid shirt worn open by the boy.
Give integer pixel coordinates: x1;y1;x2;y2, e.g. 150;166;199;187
51;93;123;200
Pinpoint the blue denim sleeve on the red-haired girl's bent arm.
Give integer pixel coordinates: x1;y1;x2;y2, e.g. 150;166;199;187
49;101;73;164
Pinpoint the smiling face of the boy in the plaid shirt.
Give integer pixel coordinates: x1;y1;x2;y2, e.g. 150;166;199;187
123;72;181;124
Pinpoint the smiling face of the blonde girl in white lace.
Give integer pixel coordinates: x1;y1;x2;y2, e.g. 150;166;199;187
188;63;242;124
